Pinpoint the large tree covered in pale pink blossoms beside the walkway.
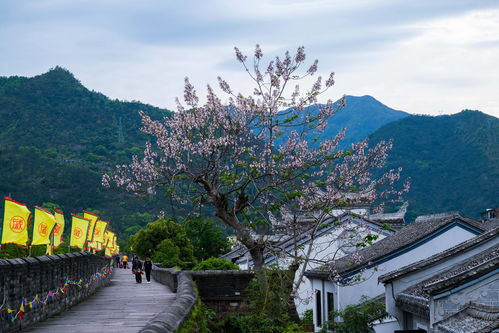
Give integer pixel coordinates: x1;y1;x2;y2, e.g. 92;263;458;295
103;45;407;278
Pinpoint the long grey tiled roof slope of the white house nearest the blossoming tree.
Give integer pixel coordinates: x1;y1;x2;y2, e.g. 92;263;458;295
306;212;484;279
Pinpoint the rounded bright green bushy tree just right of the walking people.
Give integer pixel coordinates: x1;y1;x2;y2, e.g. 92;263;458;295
130;217;196;269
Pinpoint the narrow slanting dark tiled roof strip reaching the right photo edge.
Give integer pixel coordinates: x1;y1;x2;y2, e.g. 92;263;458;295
378;227;499;283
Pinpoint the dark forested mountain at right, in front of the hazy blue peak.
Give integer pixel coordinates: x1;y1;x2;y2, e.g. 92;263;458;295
370;110;499;220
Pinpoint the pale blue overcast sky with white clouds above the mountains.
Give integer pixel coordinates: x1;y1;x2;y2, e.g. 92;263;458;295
0;0;499;117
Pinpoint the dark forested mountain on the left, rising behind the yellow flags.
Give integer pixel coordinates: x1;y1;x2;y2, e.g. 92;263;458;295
0;67;170;232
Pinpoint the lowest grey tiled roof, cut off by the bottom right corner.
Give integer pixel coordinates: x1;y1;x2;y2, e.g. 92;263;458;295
435;302;499;333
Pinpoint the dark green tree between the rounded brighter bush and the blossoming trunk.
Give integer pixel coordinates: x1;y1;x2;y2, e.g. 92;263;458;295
183;217;230;261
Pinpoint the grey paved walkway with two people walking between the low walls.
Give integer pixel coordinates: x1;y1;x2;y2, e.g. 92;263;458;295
27;269;175;333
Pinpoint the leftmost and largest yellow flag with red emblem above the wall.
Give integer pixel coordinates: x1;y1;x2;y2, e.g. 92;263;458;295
2;197;31;246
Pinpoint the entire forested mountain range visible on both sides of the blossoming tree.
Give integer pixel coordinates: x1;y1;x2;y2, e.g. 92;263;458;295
0;67;499;232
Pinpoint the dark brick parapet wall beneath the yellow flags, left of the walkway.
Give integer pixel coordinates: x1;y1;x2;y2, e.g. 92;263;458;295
0;252;110;332
